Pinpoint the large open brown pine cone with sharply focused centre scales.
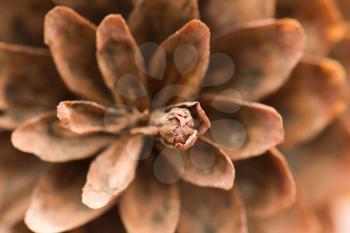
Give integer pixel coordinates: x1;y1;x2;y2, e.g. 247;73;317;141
0;0;348;233
